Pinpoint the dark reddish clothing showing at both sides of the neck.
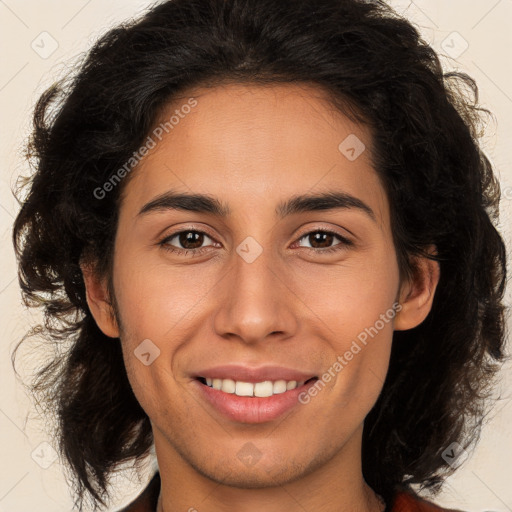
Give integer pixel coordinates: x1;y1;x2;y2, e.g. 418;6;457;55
119;473;461;512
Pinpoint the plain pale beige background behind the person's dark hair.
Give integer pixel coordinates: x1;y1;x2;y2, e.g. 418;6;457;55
0;0;512;512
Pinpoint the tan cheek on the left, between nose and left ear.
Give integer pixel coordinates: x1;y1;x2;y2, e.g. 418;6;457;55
114;251;218;416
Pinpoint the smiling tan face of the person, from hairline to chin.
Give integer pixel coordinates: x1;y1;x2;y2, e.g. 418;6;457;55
84;84;436;487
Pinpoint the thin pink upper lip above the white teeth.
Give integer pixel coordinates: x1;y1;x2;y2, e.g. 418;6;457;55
194;364;316;382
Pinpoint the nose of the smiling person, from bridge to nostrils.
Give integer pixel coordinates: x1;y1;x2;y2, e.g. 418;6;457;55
214;237;295;343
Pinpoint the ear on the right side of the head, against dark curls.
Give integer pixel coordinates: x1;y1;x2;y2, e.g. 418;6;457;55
394;246;440;331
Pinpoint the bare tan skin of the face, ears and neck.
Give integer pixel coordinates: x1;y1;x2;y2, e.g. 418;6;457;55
83;84;439;512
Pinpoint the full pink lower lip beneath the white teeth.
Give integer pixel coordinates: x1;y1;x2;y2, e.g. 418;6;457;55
194;380;316;423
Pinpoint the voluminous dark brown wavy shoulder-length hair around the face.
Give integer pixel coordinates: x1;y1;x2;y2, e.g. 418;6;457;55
13;0;506;510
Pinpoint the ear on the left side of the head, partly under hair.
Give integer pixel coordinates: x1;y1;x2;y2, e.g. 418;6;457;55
80;263;119;338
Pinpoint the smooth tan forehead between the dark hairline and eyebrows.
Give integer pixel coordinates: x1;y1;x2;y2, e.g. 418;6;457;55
118;84;387;228
